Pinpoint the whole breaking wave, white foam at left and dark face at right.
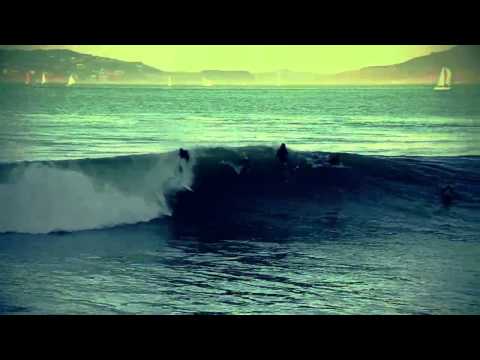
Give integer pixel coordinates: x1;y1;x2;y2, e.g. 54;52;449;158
0;147;480;233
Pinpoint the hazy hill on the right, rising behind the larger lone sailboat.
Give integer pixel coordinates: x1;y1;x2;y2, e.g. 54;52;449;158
326;45;480;84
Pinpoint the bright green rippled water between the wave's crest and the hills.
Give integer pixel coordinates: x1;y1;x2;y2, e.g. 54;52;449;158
0;86;480;160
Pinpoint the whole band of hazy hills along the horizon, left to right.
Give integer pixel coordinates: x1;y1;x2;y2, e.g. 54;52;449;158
0;45;480;85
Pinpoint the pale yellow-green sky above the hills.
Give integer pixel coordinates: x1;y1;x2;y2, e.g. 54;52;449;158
1;45;451;74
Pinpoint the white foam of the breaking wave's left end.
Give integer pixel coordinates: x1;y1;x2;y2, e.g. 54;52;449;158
0;154;193;233
